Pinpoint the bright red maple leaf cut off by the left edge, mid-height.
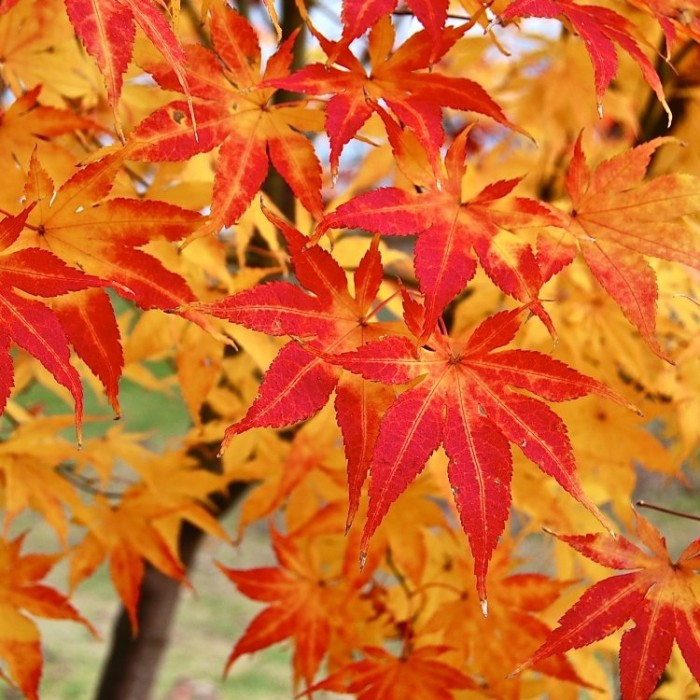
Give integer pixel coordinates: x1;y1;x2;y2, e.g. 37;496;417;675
0;204;104;432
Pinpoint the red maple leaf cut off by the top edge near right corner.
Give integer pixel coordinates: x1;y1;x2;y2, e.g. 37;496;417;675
499;0;671;124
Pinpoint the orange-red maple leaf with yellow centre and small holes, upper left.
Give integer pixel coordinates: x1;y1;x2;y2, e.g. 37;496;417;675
126;5;323;230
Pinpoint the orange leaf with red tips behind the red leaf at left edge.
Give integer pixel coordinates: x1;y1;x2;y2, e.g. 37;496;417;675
12;150;201;411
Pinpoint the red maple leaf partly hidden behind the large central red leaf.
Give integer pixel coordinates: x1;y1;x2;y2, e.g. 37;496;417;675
192;212;392;520
